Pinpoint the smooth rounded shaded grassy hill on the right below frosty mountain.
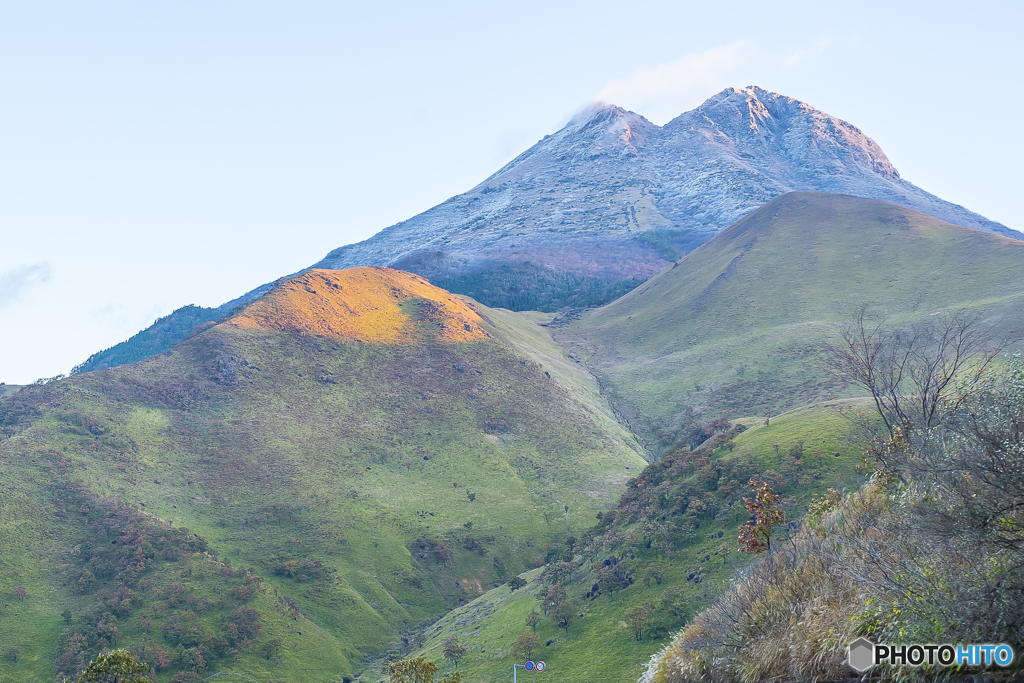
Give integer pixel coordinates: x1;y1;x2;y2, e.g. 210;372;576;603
558;193;1024;452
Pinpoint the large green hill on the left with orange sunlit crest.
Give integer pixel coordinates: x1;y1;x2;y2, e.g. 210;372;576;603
0;268;645;681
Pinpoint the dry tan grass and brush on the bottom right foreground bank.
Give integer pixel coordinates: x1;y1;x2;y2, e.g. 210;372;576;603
641;456;1021;683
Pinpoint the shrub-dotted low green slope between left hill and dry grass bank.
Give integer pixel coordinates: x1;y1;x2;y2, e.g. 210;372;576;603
387;403;863;682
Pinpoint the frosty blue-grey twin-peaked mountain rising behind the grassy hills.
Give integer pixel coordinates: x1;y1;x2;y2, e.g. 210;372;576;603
315;86;1022;310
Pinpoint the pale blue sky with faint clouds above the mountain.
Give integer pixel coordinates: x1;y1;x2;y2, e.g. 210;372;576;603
0;0;1024;384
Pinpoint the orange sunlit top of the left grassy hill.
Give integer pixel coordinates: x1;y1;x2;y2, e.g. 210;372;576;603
227;267;489;344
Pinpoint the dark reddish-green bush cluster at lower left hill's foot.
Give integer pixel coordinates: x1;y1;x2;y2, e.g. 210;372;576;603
54;482;263;680
